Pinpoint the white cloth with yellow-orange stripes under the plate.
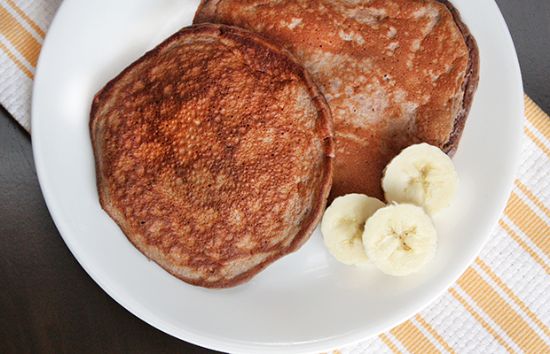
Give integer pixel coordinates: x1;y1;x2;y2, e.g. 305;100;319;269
0;0;550;353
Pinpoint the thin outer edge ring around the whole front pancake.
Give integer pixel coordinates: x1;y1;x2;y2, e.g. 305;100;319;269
89;23;334;288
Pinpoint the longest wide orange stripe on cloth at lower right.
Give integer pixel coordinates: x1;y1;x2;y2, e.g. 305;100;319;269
457;268;550;353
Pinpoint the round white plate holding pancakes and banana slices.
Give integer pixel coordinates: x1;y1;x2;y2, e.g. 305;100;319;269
32;0;523;352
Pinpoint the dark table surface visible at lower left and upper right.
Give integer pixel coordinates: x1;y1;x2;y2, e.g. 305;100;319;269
0;0;550;353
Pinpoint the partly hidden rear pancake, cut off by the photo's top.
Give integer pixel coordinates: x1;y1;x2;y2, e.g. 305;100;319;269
194;0;479;199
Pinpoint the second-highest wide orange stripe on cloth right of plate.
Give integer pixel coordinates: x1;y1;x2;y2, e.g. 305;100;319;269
504;192;550;256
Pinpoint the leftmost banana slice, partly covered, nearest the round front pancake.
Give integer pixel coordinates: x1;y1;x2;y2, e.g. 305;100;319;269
321;194;384;265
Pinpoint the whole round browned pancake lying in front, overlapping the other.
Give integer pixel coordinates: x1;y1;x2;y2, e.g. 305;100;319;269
90;25;334;288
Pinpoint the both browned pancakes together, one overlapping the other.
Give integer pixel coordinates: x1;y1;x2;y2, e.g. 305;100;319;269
90;0;479;287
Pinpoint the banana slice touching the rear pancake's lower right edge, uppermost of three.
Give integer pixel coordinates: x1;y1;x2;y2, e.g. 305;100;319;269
382;143;458;215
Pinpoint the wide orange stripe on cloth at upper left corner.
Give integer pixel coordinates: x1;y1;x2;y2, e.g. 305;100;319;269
0;6;40;66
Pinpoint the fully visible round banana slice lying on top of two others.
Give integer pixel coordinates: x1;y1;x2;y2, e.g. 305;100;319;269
363;204;437;276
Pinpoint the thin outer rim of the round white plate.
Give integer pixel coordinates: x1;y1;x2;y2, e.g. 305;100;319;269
31;0;525;353
